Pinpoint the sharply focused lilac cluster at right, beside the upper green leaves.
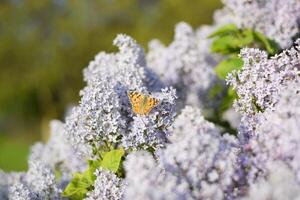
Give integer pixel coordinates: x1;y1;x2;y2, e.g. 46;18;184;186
227;40;300;115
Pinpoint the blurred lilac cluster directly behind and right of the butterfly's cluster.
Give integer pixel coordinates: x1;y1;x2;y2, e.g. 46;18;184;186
147;22;218;107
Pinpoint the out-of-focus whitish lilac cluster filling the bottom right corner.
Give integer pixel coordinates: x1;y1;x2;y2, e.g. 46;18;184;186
243;162;300;200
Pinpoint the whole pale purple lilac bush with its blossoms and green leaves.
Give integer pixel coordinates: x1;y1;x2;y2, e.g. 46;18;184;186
0;0;300;200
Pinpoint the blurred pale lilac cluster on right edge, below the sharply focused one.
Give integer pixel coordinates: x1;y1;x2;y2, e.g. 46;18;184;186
240;80;300;184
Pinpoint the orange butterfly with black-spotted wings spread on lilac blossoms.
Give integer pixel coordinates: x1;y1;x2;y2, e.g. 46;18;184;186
128;91;159;115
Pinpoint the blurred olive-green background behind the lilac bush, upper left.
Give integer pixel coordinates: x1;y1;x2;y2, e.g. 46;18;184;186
0;0;221;171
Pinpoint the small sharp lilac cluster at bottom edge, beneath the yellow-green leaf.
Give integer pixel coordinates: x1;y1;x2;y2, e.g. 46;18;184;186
85;169;125;200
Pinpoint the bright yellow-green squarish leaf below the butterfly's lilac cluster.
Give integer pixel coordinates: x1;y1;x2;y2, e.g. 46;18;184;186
101;149;125;173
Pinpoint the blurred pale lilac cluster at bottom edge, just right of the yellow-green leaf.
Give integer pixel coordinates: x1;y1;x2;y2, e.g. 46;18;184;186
124;152;192;200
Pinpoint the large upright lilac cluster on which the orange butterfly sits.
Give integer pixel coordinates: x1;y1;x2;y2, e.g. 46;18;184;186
65;35;176;158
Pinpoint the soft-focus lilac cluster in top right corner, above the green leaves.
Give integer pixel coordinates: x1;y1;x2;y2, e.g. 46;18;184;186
215;0;300;48
